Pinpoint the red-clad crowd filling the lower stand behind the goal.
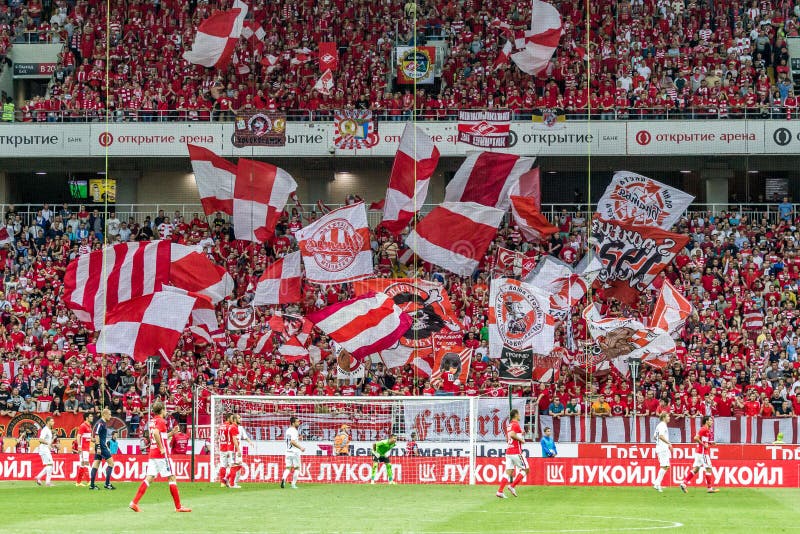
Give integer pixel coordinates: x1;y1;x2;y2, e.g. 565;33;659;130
0;196;800;444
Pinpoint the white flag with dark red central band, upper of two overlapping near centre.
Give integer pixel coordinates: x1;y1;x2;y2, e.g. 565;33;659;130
444;152;534;211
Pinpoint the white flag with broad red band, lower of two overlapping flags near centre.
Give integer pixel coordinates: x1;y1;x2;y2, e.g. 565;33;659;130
406;202;504;276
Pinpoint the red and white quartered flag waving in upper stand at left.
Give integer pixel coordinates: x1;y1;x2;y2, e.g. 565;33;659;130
183;8;244;69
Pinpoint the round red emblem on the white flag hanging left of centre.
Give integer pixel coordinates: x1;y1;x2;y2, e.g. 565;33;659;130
305;219;364;272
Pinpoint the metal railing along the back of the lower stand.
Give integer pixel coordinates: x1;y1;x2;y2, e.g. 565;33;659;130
0;199;788;226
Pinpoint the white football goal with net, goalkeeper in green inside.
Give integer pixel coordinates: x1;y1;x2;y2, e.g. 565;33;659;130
210;395;525;484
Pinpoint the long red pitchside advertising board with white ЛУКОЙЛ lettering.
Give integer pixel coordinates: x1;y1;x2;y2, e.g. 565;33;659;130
0;454;800;488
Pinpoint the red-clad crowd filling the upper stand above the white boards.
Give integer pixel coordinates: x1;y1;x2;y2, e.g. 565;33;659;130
0;0;800;121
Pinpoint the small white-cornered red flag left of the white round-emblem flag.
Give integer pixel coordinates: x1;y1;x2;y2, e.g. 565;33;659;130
169;243;233;304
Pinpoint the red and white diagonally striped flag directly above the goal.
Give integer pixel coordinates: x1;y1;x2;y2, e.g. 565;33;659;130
308;293;412;361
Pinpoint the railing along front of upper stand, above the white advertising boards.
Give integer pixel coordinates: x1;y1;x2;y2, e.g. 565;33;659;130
1;106;800;123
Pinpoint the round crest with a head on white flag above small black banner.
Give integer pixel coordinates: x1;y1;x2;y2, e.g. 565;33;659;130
494;284;545;350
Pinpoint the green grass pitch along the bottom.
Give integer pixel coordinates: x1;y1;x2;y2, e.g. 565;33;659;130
0;482;800;534
